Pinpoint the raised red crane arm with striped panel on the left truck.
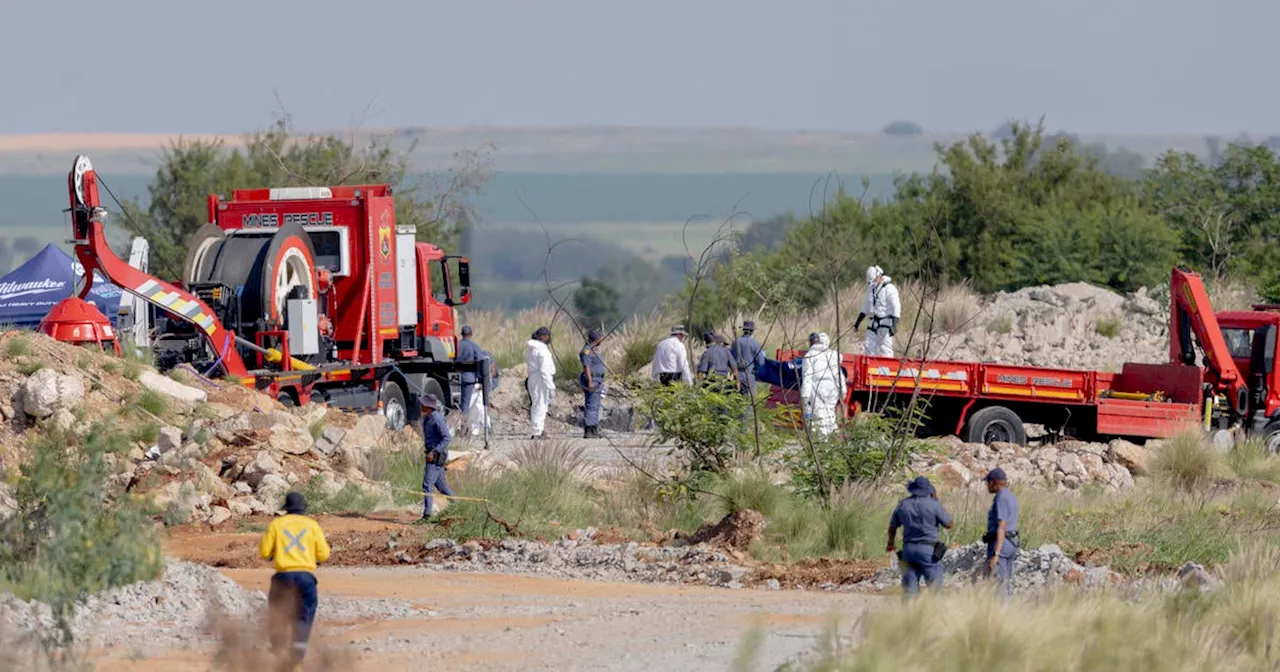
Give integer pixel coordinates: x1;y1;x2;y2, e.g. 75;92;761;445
67;155;248;378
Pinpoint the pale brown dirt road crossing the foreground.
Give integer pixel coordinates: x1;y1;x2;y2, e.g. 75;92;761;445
90;567;877;672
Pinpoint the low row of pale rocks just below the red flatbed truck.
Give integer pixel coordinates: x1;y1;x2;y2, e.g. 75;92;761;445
911;436;1149;492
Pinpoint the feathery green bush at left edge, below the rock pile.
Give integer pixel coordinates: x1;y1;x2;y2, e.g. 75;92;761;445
0;431;161;655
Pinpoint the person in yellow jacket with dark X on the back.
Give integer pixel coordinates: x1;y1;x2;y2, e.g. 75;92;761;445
259;493;329;669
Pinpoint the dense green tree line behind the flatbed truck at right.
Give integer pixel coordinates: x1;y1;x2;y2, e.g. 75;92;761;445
681;123;1280;324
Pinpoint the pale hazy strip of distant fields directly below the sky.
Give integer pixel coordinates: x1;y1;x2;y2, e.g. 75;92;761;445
0;119;1223;175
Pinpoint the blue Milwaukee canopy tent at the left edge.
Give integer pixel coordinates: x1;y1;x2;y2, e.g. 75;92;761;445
0;243;124;329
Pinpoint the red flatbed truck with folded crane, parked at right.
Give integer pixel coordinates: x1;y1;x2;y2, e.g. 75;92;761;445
771;268;1280;452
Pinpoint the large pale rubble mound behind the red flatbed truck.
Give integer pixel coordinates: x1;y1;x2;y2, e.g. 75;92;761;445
940;283;1169;370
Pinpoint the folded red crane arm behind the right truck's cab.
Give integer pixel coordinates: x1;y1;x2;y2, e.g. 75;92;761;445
1169;266;1248;413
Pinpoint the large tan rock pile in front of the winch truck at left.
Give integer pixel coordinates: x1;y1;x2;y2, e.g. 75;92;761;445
0;333;401;525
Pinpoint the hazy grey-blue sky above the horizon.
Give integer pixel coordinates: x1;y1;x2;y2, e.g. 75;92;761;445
0;0;1280;133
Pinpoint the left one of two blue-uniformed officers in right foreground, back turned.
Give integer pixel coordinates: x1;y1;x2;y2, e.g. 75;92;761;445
886;476;951;599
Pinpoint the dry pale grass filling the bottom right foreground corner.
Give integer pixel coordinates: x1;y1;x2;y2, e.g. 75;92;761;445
783;545;1280;672
